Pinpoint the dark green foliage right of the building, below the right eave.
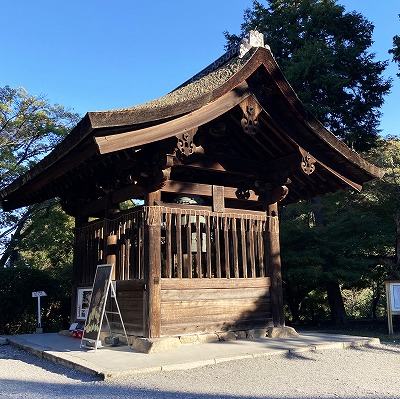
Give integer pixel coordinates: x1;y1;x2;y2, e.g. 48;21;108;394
281;138;400;321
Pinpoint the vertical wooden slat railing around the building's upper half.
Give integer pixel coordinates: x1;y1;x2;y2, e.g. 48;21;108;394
75;206;269;283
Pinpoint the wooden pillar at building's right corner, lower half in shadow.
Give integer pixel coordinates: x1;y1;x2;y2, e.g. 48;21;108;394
266;202;285;327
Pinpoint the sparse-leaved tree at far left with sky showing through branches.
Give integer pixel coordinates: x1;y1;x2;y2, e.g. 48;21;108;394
0;86;79;268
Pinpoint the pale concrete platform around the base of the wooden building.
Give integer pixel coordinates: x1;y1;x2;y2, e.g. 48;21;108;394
4;333;380;380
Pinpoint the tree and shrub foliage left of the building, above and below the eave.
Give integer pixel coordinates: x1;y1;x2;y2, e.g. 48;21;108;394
0;86;79;334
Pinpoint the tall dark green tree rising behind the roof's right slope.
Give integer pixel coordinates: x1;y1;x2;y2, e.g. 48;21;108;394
225;0;391;151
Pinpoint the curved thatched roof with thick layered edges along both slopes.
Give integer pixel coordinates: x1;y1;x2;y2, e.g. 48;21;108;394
0;37;384;211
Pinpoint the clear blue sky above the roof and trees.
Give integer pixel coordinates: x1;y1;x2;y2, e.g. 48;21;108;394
0;0;400;136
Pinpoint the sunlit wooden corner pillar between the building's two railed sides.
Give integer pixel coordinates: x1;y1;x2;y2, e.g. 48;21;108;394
143;192;161;338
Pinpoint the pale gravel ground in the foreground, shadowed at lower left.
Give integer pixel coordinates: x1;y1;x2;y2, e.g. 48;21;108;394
0;344;400;399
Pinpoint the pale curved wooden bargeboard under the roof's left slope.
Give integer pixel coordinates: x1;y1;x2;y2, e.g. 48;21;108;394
94;82;251;154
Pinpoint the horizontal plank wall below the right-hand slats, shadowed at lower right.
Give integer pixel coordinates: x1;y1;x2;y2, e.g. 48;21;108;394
161;277;271;335
